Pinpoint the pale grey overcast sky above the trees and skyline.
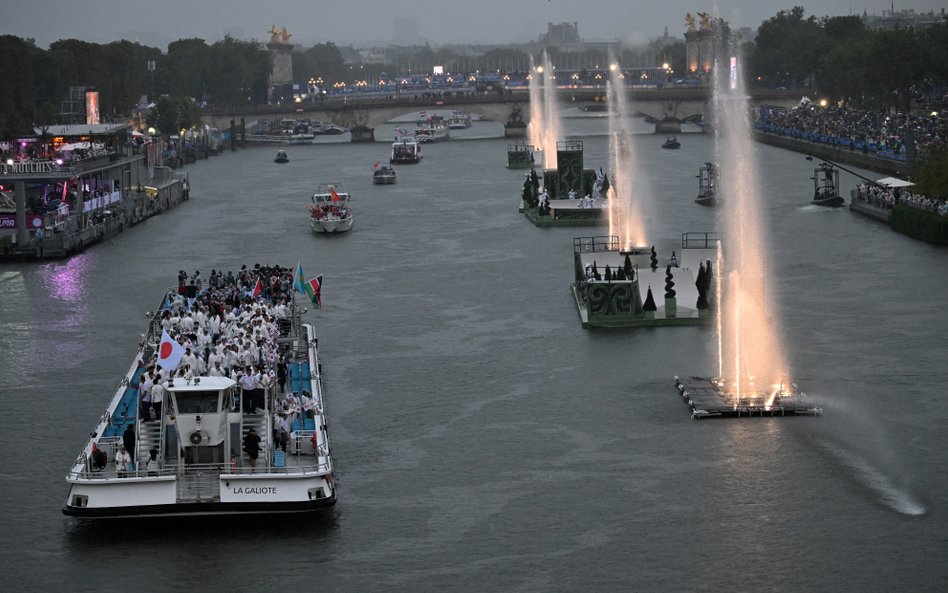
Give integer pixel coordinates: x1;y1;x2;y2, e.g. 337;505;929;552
0;0;948;50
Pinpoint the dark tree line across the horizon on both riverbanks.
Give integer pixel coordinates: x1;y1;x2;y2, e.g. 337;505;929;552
0;7;948;138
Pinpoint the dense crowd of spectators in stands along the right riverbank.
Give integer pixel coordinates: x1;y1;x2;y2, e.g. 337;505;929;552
755;102;948;160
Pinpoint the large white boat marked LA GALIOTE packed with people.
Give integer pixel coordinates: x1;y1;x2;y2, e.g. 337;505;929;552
63;282;336;518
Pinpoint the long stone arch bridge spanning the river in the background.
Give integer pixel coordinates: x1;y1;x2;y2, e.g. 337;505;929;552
202;87;802;142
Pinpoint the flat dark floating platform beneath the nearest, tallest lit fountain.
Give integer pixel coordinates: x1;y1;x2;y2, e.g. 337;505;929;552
675;377;823;420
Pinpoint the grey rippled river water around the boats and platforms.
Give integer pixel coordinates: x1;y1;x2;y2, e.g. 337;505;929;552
0;113;948;592
